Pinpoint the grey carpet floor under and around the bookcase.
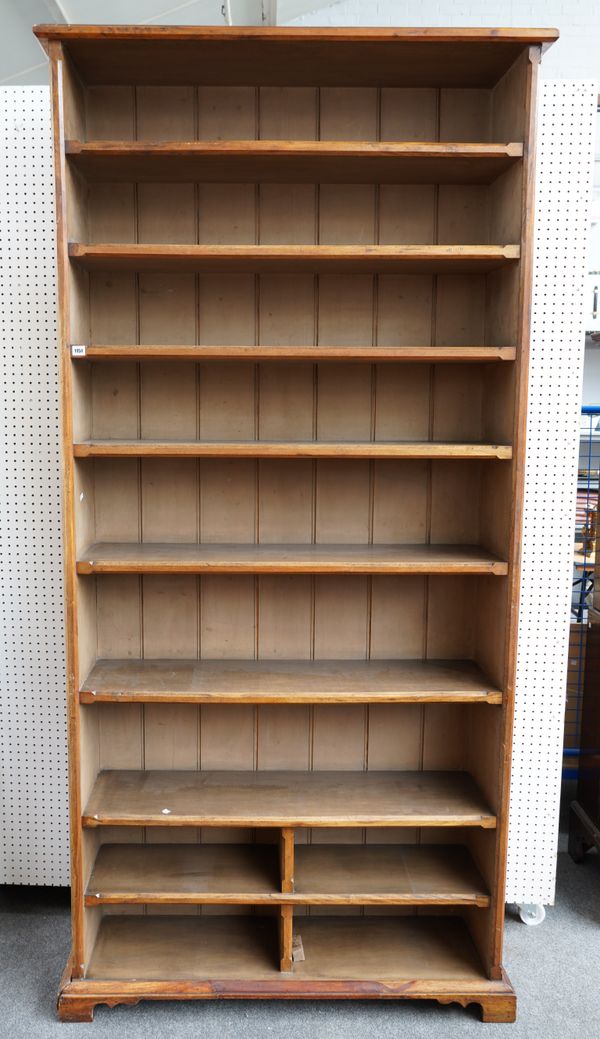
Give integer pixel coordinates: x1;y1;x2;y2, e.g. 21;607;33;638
0;852;600;1039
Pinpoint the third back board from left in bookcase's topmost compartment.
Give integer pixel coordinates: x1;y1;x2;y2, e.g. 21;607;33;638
198;85;257;140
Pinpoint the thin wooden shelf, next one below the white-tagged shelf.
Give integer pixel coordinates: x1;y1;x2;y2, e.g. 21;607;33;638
73;441;513;459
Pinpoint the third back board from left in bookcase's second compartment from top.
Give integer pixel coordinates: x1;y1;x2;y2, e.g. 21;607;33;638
198;184;256;245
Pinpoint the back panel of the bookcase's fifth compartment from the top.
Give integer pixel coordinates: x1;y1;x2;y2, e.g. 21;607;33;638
78;458;501;556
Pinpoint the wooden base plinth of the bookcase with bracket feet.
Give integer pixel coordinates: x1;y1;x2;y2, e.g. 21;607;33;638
58;961;517;1024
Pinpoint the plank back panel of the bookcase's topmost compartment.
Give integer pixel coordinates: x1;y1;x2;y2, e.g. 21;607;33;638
79;85;511;141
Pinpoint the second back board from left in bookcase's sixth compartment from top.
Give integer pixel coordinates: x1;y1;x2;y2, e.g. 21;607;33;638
141;575;199;660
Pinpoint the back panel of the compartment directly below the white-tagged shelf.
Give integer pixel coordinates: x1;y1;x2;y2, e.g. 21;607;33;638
75;361;512;445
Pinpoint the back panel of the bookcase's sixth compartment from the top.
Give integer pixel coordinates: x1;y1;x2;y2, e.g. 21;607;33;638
79;575;505;669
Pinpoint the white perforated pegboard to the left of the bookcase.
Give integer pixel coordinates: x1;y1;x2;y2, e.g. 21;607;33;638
0;86;69;884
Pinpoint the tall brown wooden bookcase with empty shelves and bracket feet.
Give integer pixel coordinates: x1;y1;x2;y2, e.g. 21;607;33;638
35;26;556;1020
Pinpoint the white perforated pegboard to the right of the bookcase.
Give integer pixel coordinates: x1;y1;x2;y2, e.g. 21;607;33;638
506;80;598;905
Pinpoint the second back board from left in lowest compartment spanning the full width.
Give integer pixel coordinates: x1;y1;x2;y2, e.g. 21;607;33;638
144;703;200;769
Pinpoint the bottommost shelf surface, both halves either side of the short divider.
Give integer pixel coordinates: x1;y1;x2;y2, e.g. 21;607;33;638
86;915;486;980
